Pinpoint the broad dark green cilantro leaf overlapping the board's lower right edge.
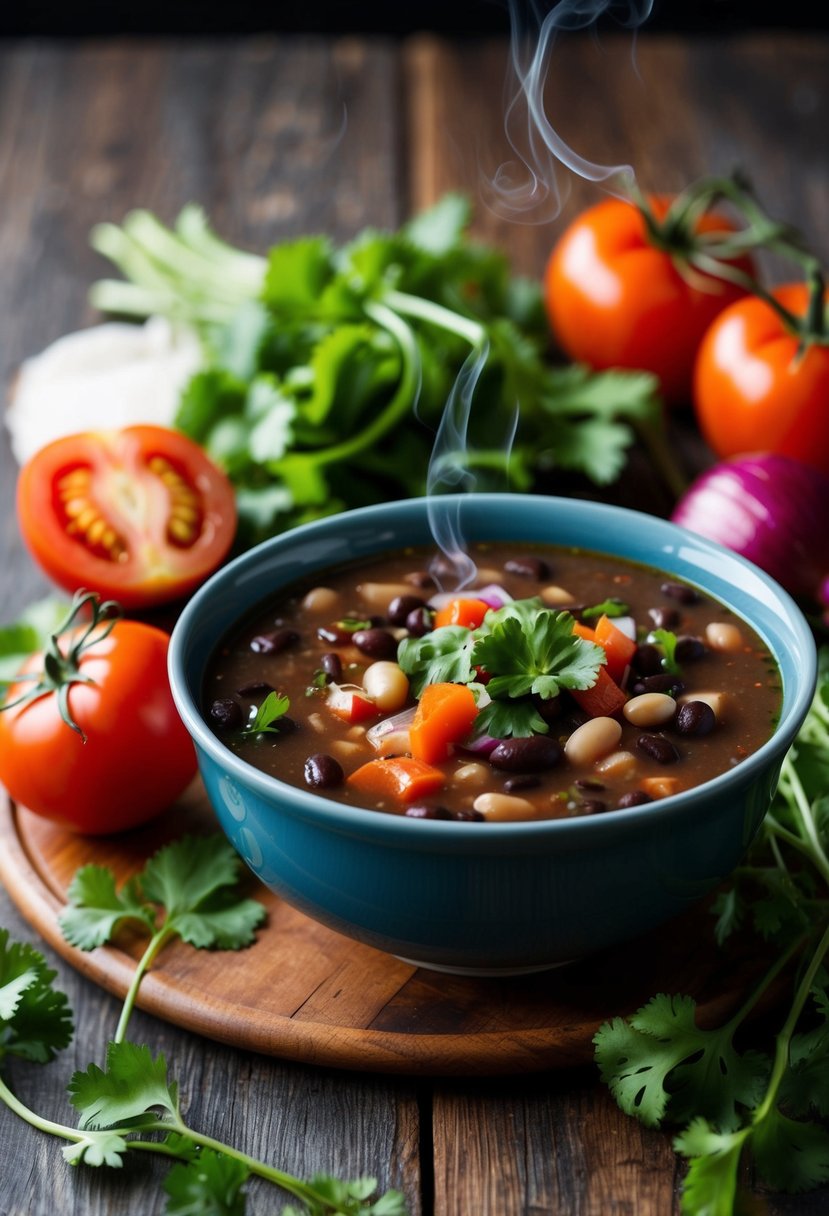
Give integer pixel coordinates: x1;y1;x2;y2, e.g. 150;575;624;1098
593;993;769;1131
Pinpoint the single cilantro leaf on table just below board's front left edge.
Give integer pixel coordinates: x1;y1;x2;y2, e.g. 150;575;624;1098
68;1042;179;1130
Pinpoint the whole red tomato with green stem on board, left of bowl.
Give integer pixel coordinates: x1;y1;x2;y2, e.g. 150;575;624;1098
0;620;196;835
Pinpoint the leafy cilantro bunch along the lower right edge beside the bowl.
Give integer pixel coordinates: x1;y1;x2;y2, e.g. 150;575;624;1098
594;647;829;1216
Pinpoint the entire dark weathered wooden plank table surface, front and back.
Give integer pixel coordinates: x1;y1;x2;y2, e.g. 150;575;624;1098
0;32;829;1216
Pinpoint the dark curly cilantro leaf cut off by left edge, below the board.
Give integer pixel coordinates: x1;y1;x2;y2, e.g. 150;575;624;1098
0;929;72;1064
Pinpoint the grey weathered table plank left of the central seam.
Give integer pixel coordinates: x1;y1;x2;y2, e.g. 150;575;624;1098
0;38;421;1216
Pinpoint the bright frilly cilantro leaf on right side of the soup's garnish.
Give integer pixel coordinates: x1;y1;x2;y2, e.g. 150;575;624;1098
472;599;605;700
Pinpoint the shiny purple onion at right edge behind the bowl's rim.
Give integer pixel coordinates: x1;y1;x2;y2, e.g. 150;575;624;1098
671;452;829;602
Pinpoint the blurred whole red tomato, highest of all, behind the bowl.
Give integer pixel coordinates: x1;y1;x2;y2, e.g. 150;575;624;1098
543;196;751;405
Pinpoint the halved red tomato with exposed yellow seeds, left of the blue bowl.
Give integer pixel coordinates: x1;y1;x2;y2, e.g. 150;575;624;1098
17;426;236;609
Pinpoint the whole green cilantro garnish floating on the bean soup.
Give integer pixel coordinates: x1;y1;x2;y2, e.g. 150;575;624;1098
397;597;607;738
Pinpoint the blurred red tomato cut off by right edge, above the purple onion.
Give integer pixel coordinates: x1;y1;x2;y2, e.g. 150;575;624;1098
694;283;829;474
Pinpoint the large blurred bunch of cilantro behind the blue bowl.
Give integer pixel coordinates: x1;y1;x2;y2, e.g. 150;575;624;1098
91;195;661;541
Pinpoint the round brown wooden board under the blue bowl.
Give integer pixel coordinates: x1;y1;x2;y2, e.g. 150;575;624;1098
0;781;756;1075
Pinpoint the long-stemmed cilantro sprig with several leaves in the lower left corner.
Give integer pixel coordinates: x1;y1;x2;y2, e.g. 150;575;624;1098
0;835;406;1216
